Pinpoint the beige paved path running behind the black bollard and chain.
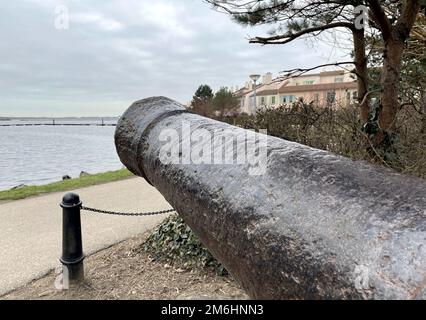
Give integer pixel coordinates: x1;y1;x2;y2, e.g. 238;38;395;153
0;178;170;295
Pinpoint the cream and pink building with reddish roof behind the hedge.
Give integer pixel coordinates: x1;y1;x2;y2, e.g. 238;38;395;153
235;70;357;114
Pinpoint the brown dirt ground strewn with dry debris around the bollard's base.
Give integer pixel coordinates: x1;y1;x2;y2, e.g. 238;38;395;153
0;235;248;300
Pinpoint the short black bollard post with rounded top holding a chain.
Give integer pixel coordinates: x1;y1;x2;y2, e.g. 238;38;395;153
60;193;84;284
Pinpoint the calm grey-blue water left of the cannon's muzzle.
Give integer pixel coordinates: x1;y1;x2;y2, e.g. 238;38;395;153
0;121;123;190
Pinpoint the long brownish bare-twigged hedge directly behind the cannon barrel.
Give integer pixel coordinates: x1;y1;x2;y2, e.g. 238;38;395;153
231;101;426;178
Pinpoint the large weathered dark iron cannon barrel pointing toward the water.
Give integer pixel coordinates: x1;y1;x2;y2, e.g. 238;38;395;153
115;97;426;299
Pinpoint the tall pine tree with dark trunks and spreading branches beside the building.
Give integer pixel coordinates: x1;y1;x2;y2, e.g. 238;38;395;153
205;0;421;142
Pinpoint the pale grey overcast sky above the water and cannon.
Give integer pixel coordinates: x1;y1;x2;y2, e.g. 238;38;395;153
0;0;350;117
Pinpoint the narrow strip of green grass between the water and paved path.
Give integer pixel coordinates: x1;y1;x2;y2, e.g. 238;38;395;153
0;169;133;201
